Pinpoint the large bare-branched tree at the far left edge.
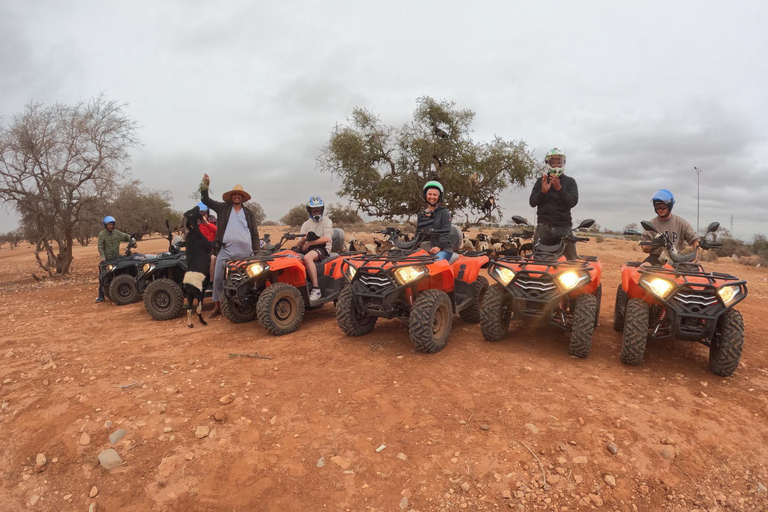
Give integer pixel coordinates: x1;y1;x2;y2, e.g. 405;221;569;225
0;96;140;276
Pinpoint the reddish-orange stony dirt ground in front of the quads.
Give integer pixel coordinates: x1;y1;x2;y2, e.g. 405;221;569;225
0;233;768;512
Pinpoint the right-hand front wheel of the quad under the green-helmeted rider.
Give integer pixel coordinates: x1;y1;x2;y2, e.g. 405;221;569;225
408;290;453;354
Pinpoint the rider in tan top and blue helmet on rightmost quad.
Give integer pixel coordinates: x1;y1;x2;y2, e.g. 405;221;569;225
641;188;701;266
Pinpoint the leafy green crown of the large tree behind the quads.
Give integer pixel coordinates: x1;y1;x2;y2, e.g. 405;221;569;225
318;96;541;224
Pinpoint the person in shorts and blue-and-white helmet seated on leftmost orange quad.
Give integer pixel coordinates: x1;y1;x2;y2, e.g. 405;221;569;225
298;196;333;302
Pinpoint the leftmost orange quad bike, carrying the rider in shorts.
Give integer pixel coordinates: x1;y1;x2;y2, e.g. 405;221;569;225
221;229;354;336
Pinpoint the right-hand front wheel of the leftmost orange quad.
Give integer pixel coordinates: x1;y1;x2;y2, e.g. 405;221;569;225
256;283;304;336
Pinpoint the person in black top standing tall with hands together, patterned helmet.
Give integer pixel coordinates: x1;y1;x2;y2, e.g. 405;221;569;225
529;148;579;260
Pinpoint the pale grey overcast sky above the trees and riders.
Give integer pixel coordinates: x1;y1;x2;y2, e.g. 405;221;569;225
0;0;768;239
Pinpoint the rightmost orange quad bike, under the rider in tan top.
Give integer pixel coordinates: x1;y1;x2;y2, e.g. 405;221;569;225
613;221;747;377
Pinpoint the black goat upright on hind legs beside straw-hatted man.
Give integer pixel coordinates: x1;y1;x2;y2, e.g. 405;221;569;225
183;206;211;327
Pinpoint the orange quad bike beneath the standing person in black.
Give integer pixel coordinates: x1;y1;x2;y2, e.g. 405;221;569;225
480;219;603;358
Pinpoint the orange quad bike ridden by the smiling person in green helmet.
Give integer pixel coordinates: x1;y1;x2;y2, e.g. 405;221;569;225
336;226;488;353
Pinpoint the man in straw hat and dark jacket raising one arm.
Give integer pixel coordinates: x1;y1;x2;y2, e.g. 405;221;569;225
200;174;259;318
